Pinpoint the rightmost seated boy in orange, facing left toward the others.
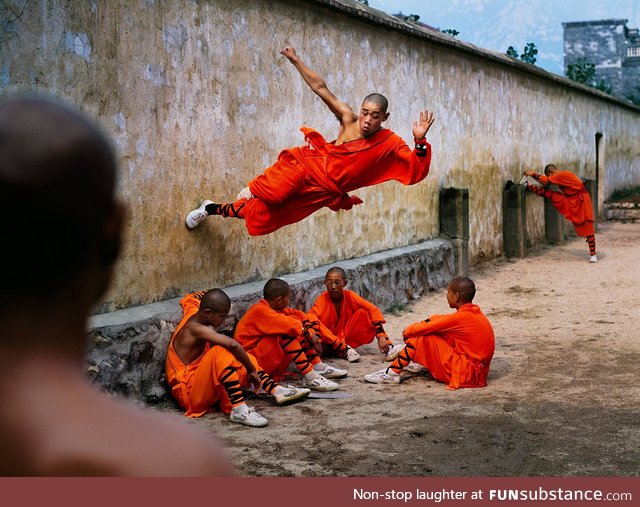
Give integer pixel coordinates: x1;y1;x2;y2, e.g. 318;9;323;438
365;277;495;389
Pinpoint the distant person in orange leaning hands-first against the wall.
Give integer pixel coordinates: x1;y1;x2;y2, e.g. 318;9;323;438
524;164;598;262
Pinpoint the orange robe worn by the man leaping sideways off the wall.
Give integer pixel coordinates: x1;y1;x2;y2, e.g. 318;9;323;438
242;127;431;236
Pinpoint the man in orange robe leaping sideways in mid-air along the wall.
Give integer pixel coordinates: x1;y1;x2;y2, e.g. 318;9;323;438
186;47;434;236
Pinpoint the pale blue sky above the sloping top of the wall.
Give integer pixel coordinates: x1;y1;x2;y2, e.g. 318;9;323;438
369;0;640;75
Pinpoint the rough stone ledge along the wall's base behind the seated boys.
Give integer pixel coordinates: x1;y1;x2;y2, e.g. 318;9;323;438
87;239;455;403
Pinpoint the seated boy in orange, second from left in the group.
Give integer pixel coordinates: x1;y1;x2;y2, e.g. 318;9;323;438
234;278;347;391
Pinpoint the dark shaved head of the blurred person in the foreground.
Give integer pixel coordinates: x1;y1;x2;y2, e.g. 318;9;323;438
0;97;119;297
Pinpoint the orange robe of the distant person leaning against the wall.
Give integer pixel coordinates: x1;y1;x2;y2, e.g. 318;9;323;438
536;171;595;236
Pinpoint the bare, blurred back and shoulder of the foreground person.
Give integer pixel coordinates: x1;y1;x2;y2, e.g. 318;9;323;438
0;363;232;477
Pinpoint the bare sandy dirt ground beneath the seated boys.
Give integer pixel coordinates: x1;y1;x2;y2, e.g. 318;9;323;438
175;223;640;477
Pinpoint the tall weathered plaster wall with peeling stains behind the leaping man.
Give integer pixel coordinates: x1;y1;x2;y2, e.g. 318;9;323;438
0;0;640;311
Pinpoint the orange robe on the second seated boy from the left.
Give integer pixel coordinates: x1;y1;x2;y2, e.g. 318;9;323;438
234;299;311;380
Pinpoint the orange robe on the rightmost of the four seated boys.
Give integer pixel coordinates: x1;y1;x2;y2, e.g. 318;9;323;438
403;303;495;389
